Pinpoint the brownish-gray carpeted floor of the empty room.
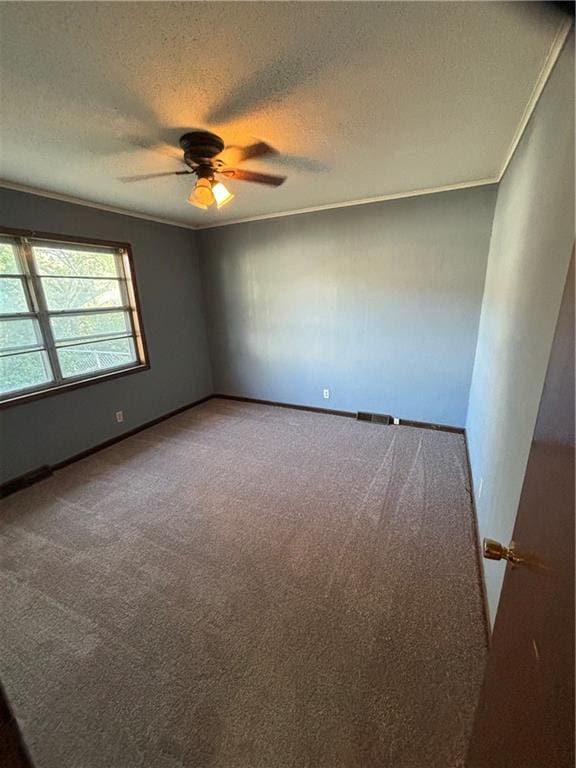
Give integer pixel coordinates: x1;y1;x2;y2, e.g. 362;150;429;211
0;400;486;768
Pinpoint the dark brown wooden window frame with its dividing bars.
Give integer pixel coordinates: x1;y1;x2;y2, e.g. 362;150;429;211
0;226;150;410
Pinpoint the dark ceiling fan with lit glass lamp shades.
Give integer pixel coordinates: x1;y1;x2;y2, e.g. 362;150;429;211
121;131;286;210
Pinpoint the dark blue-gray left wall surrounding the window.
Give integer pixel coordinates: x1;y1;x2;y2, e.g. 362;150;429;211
0;189;212;482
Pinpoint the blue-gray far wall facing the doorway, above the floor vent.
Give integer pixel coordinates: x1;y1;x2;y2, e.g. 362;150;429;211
199;187;496;426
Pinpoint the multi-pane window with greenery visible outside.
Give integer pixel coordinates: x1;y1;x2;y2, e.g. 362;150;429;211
0;228;146;402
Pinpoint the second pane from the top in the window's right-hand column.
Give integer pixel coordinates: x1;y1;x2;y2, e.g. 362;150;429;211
42;277;123;310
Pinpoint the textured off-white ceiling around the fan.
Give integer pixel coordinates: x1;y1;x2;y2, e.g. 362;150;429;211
0;2;563;226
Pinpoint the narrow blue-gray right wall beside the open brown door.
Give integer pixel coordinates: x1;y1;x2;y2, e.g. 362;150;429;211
466;37;574;620
